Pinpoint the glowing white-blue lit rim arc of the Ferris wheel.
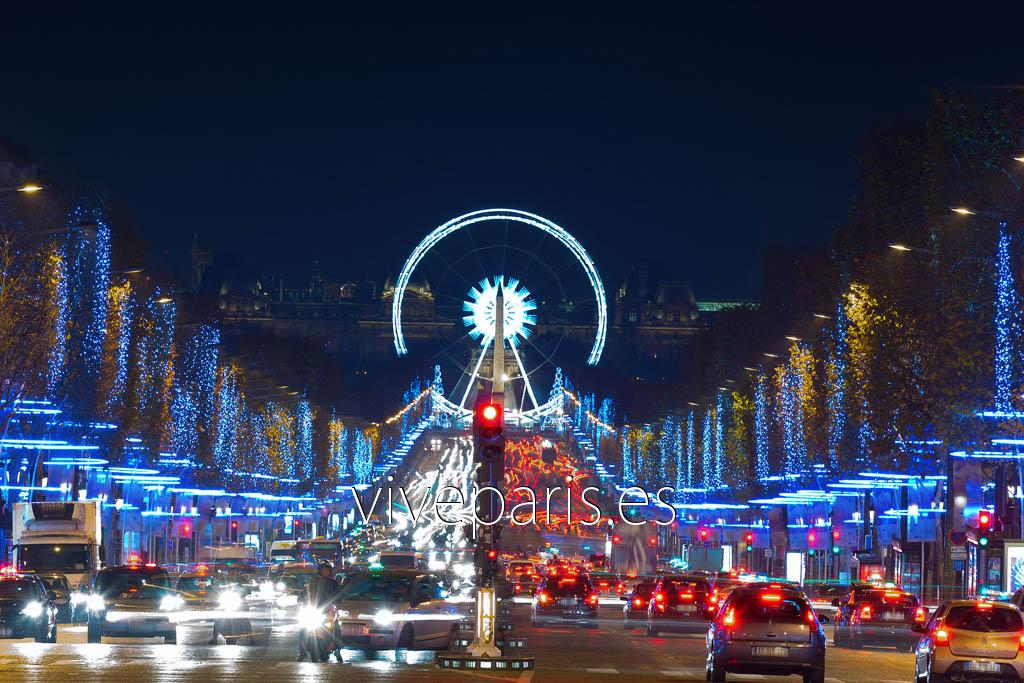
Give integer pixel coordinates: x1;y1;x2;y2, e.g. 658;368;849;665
391;209;608;366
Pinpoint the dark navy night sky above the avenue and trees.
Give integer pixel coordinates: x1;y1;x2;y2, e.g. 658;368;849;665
0;3;1024;297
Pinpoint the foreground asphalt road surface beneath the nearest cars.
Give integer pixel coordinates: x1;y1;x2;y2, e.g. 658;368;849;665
0;605;913;683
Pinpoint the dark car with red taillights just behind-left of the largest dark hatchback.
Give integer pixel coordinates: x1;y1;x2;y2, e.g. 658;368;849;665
647;574;718;638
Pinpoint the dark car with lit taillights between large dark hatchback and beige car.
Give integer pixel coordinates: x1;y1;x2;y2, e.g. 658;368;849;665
831;589;928;651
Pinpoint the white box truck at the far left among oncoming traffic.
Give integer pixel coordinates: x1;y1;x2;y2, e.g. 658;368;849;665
12;501;102;590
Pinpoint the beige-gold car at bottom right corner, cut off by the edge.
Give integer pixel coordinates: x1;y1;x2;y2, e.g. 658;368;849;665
914;600;1024;683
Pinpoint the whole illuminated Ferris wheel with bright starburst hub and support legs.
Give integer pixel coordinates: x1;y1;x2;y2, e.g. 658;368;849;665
385;209;607;423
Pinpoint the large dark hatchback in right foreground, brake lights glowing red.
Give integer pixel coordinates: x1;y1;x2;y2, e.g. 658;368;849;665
707;587;825;683
